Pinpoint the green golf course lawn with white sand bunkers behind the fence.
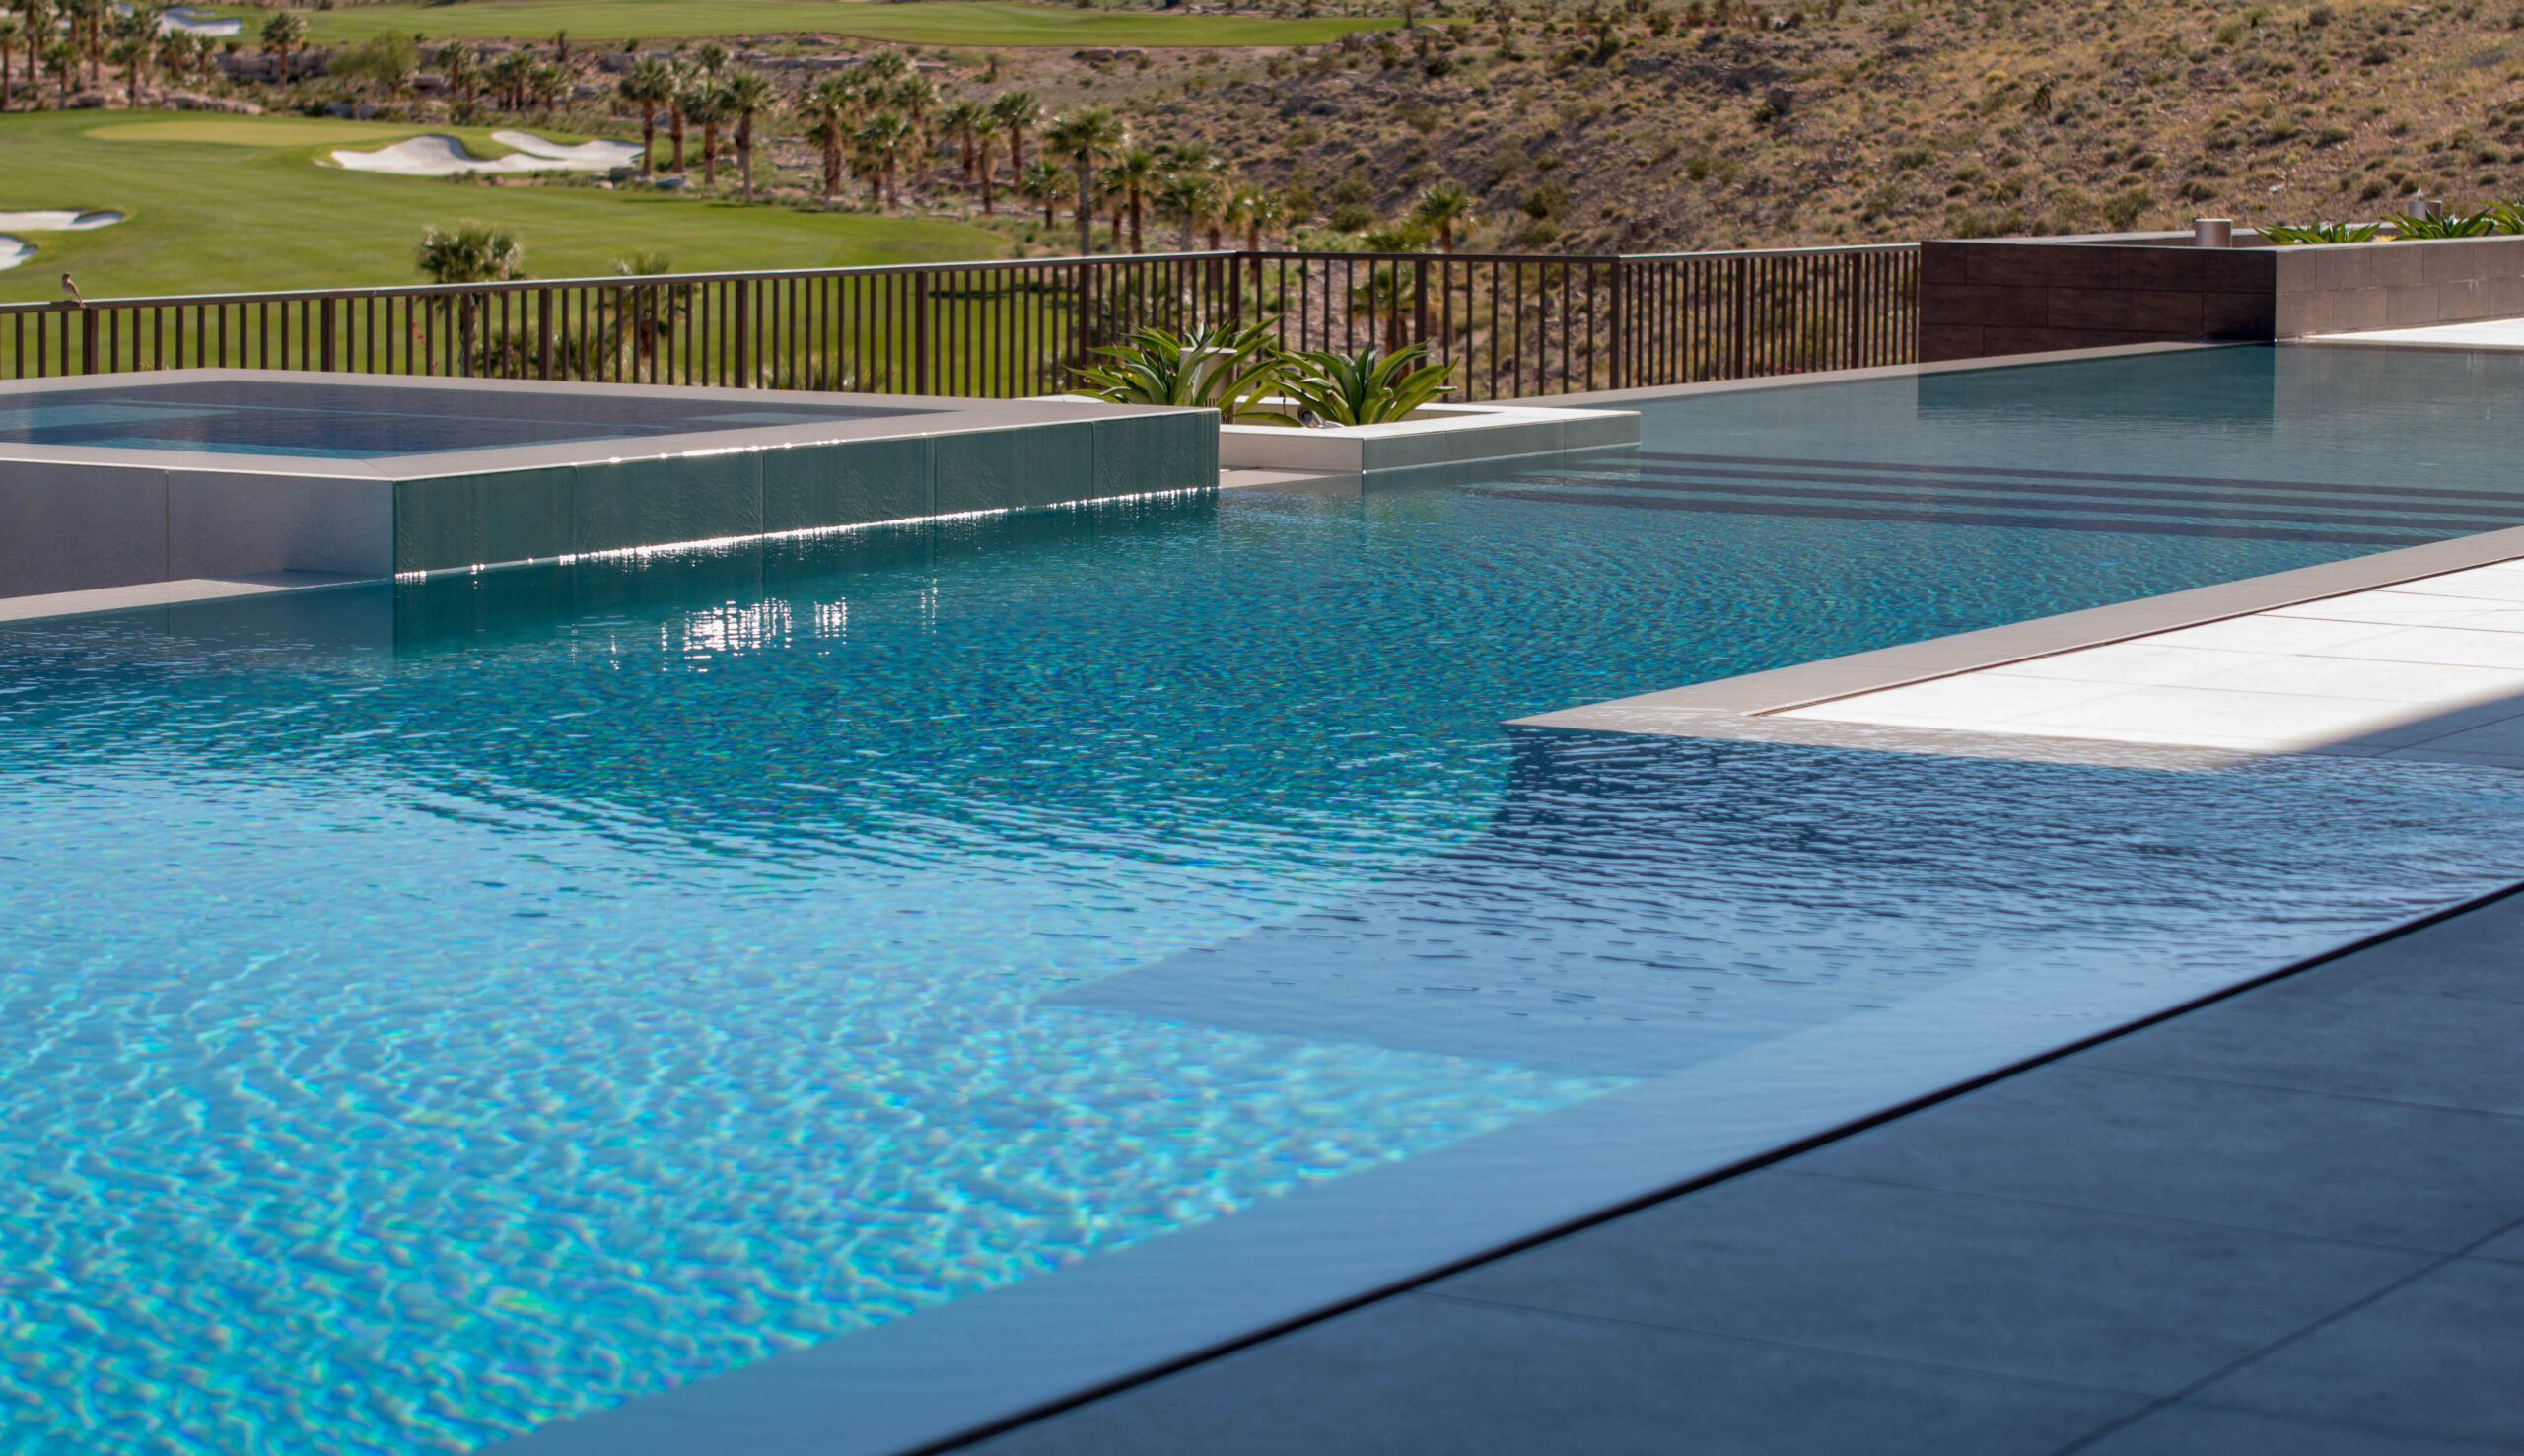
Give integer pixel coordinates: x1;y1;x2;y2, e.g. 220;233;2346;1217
0;111;1007;303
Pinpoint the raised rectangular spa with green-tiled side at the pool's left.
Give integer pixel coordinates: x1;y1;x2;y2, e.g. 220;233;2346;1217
0;369;1219;595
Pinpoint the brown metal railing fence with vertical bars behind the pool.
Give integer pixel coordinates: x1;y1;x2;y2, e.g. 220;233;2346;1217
0;244;1919;398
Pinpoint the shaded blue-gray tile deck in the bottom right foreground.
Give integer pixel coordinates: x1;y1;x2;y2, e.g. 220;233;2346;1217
964;896;2524;1456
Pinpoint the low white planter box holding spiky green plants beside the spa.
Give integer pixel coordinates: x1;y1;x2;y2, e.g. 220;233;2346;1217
1219;404;1638;474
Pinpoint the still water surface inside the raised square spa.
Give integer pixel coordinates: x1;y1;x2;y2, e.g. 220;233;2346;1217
0;379;932;459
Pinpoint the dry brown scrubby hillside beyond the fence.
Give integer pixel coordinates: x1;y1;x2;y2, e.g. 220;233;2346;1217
1105;0;2524;249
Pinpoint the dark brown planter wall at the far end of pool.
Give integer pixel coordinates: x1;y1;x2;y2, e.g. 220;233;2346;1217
1919;230;2524;364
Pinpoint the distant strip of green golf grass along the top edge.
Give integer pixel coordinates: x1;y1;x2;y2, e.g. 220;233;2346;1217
199;0;1401;48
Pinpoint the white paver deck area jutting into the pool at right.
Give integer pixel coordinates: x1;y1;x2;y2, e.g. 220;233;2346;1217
1777;552;2524;767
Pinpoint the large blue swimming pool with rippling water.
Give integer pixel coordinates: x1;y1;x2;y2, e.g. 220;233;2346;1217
15;351;2524;1456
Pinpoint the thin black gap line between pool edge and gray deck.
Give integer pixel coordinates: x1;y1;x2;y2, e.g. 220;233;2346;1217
918;880;2524;1456
